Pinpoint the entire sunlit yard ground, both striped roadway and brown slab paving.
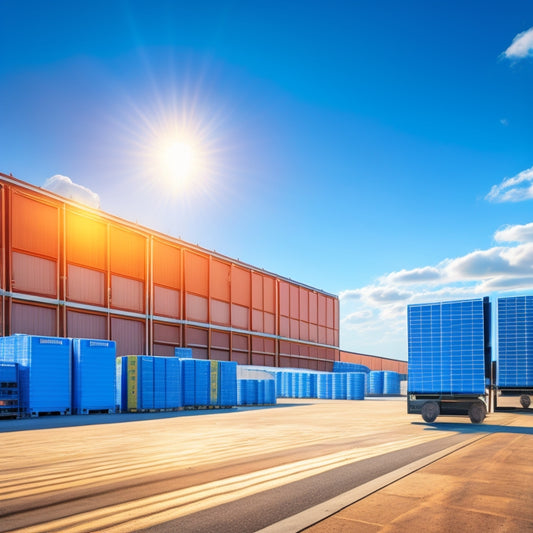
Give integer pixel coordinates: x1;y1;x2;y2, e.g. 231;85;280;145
0;398;533;532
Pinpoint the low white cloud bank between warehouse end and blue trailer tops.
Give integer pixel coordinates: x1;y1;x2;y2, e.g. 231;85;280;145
340;222;533;359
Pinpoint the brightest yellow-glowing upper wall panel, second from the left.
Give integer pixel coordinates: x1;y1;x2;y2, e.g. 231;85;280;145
65;210;107;270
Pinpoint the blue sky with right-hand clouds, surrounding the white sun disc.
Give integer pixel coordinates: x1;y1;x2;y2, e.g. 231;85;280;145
0;0;533;358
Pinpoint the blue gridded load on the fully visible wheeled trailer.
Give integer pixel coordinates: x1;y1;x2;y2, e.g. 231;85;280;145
407;298;490;395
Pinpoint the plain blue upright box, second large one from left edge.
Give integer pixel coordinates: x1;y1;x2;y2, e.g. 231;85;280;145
72;339;116;414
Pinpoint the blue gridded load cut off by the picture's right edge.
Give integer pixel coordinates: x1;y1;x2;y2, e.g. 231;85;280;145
497;296;533;388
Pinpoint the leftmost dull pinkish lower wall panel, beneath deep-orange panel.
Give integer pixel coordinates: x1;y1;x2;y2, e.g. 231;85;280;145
12;252;57;297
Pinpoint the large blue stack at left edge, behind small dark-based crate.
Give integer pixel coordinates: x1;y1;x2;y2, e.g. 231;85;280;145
0;335;72;416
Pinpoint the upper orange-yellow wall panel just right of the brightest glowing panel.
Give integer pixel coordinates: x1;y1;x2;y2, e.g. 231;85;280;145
109;225;146;280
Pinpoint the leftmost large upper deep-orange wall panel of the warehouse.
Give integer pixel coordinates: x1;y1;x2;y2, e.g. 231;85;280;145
11;191;59;259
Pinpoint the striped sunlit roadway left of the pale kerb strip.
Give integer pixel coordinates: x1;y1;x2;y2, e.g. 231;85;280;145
0;399;516;533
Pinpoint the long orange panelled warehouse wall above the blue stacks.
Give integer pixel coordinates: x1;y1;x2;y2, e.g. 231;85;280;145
0;174;339;370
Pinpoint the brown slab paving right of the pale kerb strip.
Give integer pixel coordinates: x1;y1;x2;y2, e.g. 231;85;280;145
305;406;533;533
